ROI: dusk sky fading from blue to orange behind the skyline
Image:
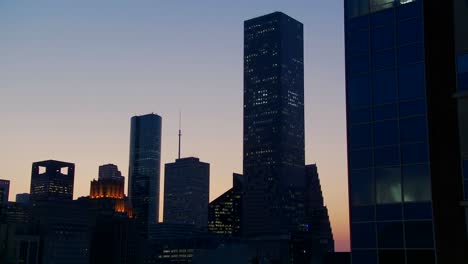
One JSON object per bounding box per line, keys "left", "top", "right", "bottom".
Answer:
{"left": 0, "top": 0, "right": 349, "bottom": 251}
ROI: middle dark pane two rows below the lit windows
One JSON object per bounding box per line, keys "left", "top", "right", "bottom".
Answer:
{"left": 377, "top": 222, "right": 403, "bottom": 250}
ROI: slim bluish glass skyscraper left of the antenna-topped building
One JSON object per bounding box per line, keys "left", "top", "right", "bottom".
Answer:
{"left": 128, "top": 114, "right": 161, "bottom": 235}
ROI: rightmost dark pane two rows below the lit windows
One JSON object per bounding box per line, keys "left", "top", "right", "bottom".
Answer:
{"left": 405, "top": 221, "right": 434, "bottom": 249}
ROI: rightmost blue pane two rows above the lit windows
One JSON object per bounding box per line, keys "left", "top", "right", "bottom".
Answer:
{"left": 400, "top": 117, "right": 427, "bottom": 143}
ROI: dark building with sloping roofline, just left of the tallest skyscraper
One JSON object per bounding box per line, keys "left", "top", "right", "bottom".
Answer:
{"left": 208, "top": 173, "right": 244, "bottom": 237}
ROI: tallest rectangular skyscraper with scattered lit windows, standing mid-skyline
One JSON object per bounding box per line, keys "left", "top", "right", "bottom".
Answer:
{"left": 243, "top": 12, "right": 305, "bottom": 237}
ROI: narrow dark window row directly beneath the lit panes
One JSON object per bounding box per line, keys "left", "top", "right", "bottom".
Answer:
{"left": 351, "top": 202, "right": 432, "bottom": 223}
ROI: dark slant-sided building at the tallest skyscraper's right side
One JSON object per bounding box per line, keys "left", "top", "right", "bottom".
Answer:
{"left": 306, "top": 164, "right": 335, "bottom": 252}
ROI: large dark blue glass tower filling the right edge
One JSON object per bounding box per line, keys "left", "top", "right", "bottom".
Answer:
{"left": 345, "top": 0, "right": 468, "bottom": 264}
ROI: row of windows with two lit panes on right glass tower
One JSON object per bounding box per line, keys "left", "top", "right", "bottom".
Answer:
{"left": 349, "top": 164, "right": 431, "bottom": 205}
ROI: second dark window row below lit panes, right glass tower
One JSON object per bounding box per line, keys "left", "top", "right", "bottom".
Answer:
{"left": 351, "top": 221, "right": 434, "bottom": 250}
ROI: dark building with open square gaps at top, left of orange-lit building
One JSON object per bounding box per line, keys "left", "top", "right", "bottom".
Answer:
{"left": 30, "top": 160, "right": 75, "bottom": 201}
